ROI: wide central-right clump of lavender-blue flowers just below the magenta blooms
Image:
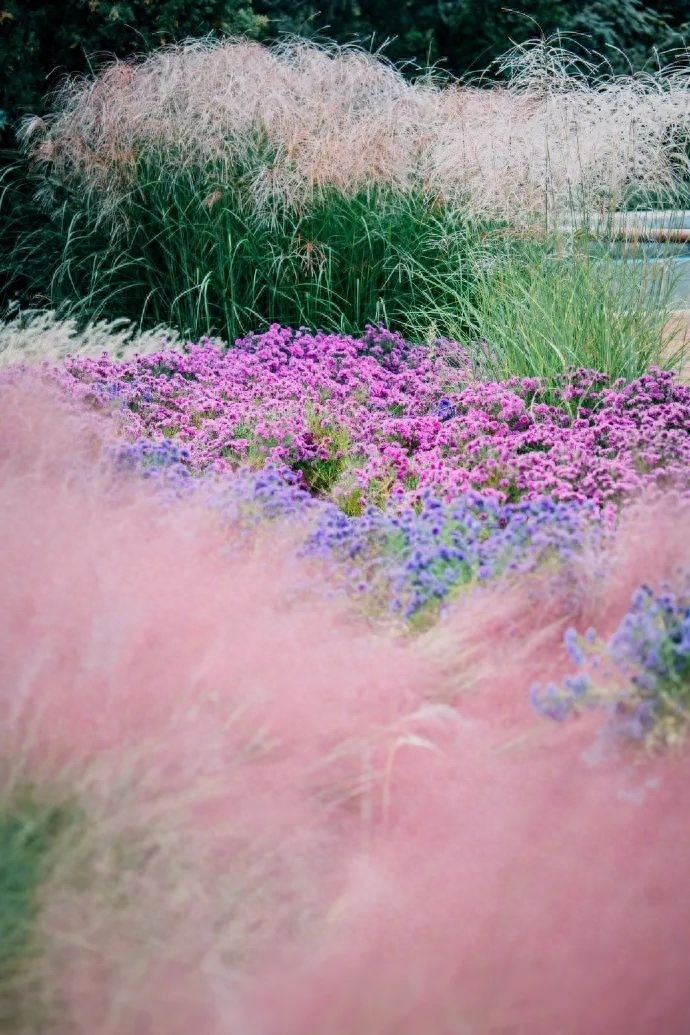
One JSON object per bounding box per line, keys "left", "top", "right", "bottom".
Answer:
{"left": 305, "top": 492, "right": 609, "bottom": 619}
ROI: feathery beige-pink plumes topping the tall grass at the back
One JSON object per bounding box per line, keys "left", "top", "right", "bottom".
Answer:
{"left": 24, "top": 38, "right": 690, "bottom": 221}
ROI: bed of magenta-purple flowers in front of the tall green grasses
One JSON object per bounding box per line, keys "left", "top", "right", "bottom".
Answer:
{"left": 55, "top": 325, "right": 690, "bottom": 513}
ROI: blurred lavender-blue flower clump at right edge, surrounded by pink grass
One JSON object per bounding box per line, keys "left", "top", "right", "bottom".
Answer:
{"left": 531, "top": 579, "right": 690, "bottom": 744}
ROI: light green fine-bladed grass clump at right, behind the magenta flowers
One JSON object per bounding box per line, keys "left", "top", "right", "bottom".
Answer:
{"left": 405, "top": 241, "right": 668, "bottom": 379}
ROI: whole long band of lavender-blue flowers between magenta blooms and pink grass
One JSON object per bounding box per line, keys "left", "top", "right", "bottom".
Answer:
{"left": 105, "top": 430, "right": 610, "bottom": 620}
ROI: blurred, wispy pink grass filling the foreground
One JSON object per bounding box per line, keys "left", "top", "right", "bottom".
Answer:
{"left": 0, "top": 377, "right": 690, "bottom": 1035}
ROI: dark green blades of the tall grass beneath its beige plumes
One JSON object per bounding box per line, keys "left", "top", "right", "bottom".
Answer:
{"left": 0, "top": 148, "right": 496, "bottom": 341}
